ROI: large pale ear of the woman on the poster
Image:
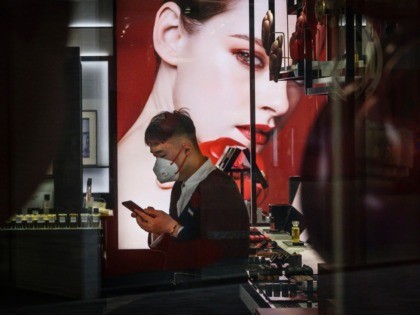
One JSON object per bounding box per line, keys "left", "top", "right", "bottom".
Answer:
{"left": 153, "top": 2, "right": 183, "bottom": 66}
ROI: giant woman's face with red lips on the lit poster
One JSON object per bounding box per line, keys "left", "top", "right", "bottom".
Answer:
{"left": 174, "top": 0, "right": 303, "bottom": 151}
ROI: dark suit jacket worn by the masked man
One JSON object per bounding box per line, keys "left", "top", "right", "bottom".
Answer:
{"left": 151, "top": 169, "right": 249, "bottom": 271}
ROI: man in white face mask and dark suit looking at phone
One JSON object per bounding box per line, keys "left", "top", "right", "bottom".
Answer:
{"left": 132, "top": 109, "right": 249, "bottom": 275}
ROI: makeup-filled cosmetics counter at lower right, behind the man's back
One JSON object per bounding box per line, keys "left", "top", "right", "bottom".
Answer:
{"left": 240, "top": 227, "right": 323, "bottom": 314}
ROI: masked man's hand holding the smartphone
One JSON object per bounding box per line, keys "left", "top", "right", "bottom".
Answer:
{"left": 131, "top": 207, "right": 177, "bottom": 234}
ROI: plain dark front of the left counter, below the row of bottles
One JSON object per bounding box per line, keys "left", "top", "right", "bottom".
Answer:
{"left": 0, "top": 229, "right": 102, "bottom": 299}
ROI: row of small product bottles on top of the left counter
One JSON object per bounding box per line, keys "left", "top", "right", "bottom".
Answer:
{"left": 3, "top": 208, "right": 101, "bottom": 229}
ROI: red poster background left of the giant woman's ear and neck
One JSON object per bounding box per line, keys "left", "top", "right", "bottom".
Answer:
{"left": 116, "top": 0, "right": 162, "bottom": 140}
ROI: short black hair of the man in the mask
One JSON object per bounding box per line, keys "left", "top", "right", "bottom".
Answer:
{"left": 144, "top": 108, "right": 198, "bottom": 147}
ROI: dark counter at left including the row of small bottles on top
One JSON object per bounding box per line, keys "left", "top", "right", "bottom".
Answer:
{"left": 0, "top": 210, "right": 110, "bottom": 299}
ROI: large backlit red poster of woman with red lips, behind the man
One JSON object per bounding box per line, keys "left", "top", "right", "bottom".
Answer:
{"left": 116, "top": 0, "right": 321, "bottom": 249}
